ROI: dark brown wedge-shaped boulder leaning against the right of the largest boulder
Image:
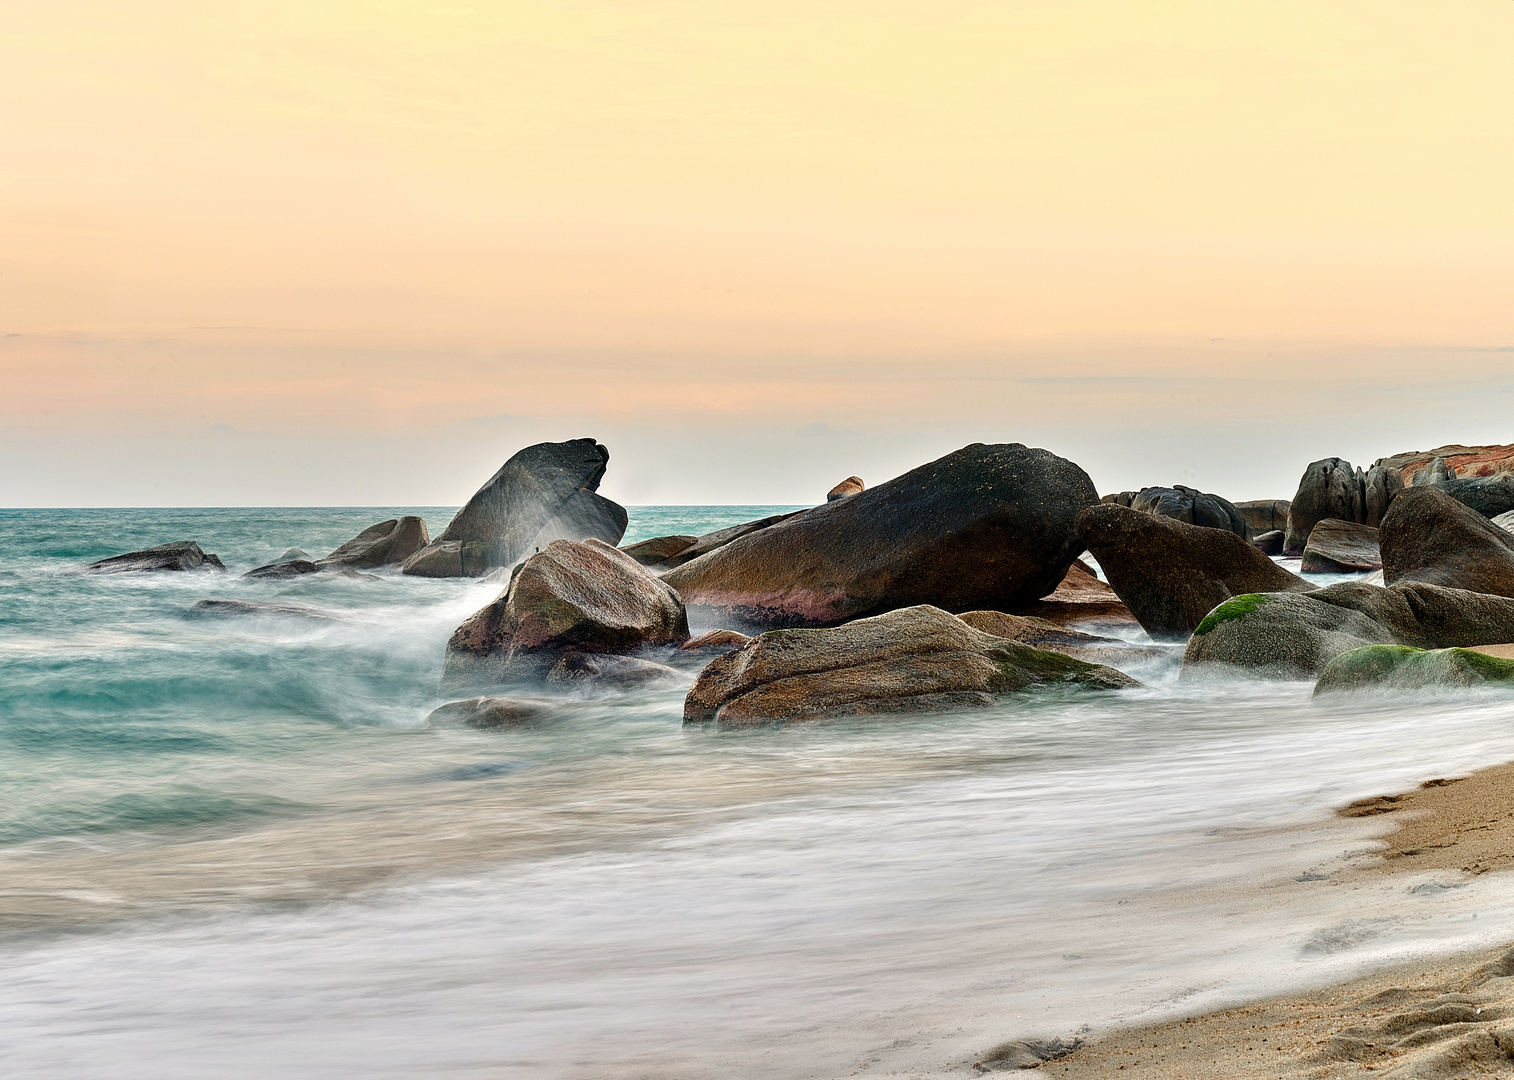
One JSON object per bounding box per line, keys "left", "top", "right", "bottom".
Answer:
{"left": 1078, "top": 504, "right": 1314, "bottom": 638}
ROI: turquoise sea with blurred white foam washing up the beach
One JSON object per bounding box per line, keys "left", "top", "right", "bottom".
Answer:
{"left": 0, "top": 506, "right": 1514, "bottom": 1078}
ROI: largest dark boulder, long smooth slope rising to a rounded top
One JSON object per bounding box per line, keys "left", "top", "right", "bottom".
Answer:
{"left": 663, "top": 442, "right": 1098, "bottom": 627}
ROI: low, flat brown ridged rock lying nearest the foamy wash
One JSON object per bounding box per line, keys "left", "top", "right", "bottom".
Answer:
{"left": 683, "top": 605, "right": 1140, "bottom": 724}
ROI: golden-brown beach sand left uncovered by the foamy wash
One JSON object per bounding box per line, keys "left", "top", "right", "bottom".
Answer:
{"left": 1029, "top": 763, "right": 1514, "bottom": 1080}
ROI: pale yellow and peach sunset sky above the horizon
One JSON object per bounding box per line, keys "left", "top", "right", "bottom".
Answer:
{"left": 0, "top": 0, "right": 1514, "bottom": 506}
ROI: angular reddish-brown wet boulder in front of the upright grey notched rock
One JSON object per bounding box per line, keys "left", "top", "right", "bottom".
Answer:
{"left": 442, "top": 539, "right": 689, "bottom": 686}
